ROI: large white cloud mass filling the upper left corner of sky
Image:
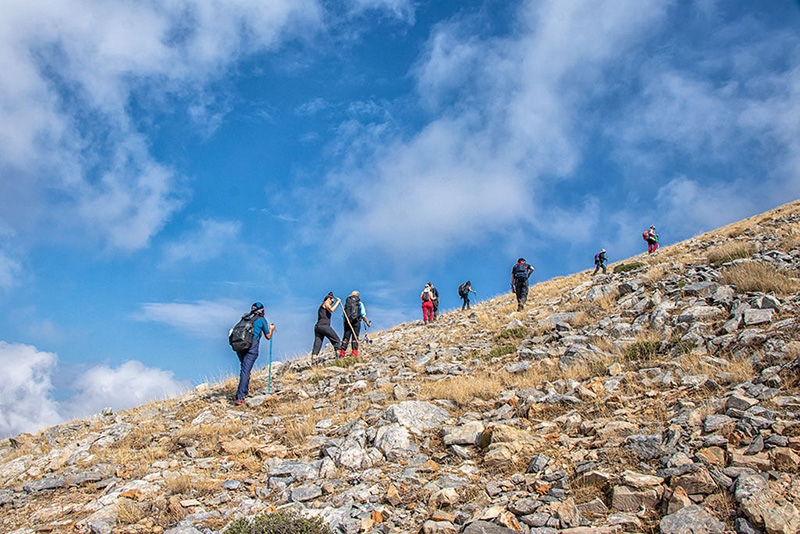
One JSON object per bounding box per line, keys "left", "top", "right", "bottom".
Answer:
{"left": 0, "top": 0, "right": 321, "bottom": 250}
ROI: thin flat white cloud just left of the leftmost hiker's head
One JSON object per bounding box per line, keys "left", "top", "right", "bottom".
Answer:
{"left": 133, "top": 300, "right": 244, "bottom": 339}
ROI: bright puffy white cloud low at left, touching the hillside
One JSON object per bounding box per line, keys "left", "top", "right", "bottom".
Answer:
{"left": 0, "top": 341, "right": 189, "bottom": 437}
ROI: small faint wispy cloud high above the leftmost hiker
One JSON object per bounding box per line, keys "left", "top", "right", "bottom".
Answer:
{"left": 165, "top": 219, "right": 241, "bottom": 263}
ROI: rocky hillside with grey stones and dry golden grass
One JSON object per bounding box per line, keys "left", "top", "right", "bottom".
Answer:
{"left": 0, "top": 202, "right": 800, "bottom": 534}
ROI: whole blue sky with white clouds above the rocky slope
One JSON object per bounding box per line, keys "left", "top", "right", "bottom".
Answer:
{"left": 0, "top": 0, "right": 800, "bottom": 435}
